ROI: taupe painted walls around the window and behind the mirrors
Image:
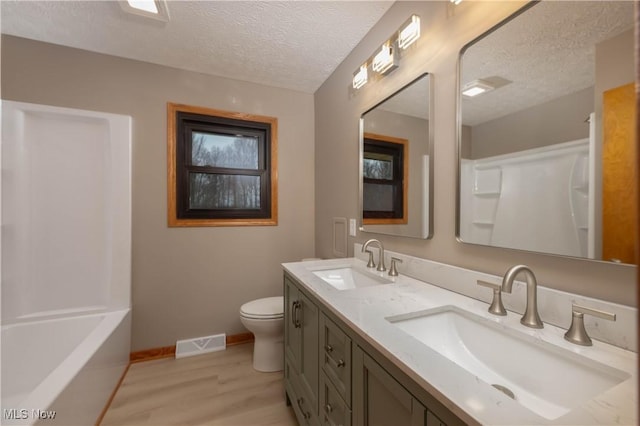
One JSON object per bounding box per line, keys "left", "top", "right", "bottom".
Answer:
{"left": 1, "top": 1, "right": 636, "bottom": 402}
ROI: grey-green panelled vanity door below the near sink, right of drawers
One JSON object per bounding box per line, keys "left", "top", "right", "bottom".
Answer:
{"left": 352, "top": 347, "right": 427, "bottom": 426}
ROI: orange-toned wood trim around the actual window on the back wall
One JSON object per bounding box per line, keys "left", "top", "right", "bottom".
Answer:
{"left": 167, "top": 102, "right": 278, "bottom": 227}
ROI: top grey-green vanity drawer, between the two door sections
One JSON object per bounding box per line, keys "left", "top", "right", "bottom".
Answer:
{"left": 320, "top": 315, "right": 351, "bottom": 407}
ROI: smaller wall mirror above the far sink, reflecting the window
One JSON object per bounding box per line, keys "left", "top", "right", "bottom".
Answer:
{"left": 359, "top": 74, "right": 433, "bottom": 238}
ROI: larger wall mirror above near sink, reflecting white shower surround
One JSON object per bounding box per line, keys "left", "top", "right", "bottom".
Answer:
{"left": 457, "top": 1, "right": 637, "bottom": 264}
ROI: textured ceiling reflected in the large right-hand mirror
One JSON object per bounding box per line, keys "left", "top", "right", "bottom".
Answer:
{"left": 461, "top": 1, "right": 634, "bottom": 126}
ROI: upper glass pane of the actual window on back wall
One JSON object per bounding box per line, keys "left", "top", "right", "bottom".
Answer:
{"left": 191, "top": 132, "right": 258, "bottom": 170}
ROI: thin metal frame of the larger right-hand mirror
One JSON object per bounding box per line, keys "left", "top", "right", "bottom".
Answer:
{"left": 455, "top": 0, "right": 636, "bottom": 267}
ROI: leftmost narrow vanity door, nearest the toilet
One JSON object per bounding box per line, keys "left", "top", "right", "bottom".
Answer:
{"left": 284, "top": 276, "right": 302, "bottom": 372}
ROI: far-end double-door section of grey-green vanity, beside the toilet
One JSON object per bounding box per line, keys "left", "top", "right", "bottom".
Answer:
{"left": 284, "top": 277, "right": 319, "bottom": 425}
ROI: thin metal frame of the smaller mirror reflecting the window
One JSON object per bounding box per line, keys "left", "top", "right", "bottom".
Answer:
{"left": 358, "top": 72, "right": 434, "bottom": 240}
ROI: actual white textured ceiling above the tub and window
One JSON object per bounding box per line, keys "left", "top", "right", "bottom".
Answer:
{"left": 0, "top": 0, "right": 393, "bottom": 93}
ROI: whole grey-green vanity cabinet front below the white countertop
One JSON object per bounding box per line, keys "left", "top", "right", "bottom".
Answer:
{"left": 284, "top": 273, "right": 463, "bottom": 426}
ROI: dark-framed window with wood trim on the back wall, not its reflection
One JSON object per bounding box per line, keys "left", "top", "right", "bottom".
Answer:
{"left": 167, "top": 103, "right": 278, "bottom": 226}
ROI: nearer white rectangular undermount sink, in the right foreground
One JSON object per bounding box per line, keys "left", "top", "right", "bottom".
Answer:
{"left": 386, "top": 306, "right": 631, "bottom": 420}
